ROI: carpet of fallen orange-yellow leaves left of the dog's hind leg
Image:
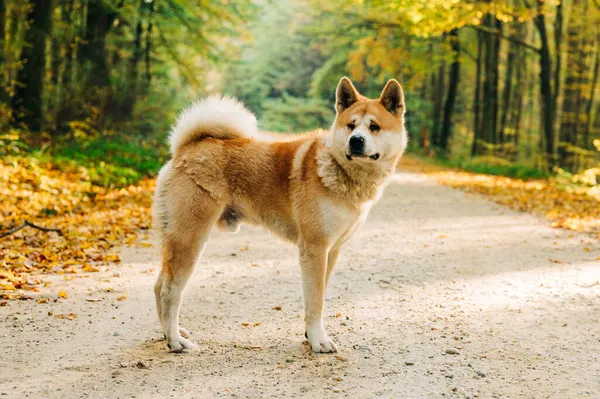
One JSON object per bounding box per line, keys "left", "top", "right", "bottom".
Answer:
{"left": 0, "top": 157, "right": 154, "bottom": 298}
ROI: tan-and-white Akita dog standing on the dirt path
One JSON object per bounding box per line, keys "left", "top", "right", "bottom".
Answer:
{"left": 153, "top": 77, "right": 408, "bottom": 353}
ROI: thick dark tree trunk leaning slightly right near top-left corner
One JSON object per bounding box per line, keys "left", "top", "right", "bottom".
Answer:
{"left": 12, "top": 0, "right": 52, "bottom": 132}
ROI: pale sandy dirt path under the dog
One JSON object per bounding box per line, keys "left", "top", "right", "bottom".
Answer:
{"left": 0, "top": 173, "right": 600, "bottom": 399}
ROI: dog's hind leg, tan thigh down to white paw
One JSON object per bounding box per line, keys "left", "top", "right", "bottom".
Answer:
{"left": 155, "top": 194, "right": 223, "bottom": 352}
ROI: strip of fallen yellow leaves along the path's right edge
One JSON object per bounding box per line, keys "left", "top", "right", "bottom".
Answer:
{"left": 400, "top": 157, "right": 600, "bottom": 238}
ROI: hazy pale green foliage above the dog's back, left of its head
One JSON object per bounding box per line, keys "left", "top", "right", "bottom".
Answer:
{"left": 224, "top": 1, "right": 332, "bottom": 132}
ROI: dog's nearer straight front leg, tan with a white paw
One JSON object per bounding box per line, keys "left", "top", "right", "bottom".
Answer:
{"left": 300, "top": 243, "right": 337, "bottom": 353}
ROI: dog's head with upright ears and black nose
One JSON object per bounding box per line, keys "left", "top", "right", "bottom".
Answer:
{"left": 328, "top": 77, "right": 407, "bottom": 166}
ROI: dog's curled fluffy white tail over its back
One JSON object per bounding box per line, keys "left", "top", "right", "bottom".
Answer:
{"left": 169, "top": 94, "right": 257, "bottom": 155}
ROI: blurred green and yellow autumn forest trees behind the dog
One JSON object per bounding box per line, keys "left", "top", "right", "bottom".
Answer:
{"left": 0, "top": 0, "right": 600, "bottom": 178}
